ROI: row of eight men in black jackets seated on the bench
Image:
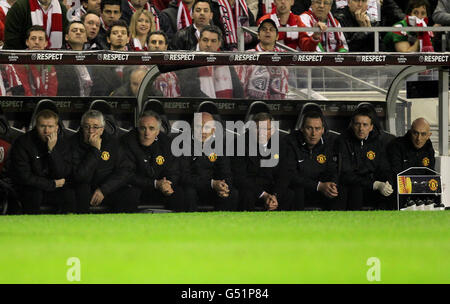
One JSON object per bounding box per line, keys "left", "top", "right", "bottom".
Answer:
{"left": 0, "top": 100, "right": 435, "bottom": 214}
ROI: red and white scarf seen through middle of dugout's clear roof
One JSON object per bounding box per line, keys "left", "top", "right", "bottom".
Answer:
{"left": 198, "top": 66, "right": 233, "bottom": 98}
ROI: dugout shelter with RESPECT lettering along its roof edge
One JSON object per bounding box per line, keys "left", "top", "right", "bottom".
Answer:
{"left": 0, "top": 50, "right": 450, "bottom": 205}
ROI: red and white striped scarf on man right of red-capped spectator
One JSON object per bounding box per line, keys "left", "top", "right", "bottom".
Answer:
{"left": 300, "top": 8, "right": 348, "bottom": 52}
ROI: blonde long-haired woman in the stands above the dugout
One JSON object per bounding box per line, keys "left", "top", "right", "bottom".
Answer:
{"left": 130, "top": 10, "right": 155, "bottom": 51}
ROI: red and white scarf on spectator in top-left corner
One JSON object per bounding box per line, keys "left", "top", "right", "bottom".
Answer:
{"left": 28, "top": 0, "right": 65, "bottom": 49}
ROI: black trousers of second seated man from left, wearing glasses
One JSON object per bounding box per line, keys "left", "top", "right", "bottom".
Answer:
{"left": 74, "top": 184, "right": 139, "bottom": 213}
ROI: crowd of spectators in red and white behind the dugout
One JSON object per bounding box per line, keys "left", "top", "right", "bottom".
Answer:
{"left": 0, "top": 0, "right": 450, "bottom": 99}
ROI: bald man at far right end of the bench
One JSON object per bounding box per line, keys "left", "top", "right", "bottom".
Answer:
{"left": 387, "top": 117, "right": 435, "bottom": 180}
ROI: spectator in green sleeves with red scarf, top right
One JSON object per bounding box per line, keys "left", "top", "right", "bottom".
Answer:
{"left": 384, "top": 0, "right": 434, "bottom": 53}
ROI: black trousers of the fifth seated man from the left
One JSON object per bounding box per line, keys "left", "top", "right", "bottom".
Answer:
{"left": 238, "top": 188, "right": 294, "bottom": 211}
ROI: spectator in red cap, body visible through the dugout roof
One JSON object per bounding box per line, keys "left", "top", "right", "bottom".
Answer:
{"left": 236, "top": 18, "right": 289, "bottom": 100}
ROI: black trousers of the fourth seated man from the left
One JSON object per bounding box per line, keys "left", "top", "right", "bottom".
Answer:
{"left": 184, "top": 187, "right": 239, "bottom": 211}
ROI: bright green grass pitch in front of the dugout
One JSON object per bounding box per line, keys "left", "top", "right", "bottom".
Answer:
{"left": 0, "top": 211, "right": 450, "bottom": 284}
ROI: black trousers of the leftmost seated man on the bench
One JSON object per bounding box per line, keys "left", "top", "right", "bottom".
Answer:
{"left": 18, "top": 186, "right": 76, "bottom": 214}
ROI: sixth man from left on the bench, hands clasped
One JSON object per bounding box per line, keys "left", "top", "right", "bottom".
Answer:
{"left": 286, "top": 111, "right": 345, "bottom": 210}
